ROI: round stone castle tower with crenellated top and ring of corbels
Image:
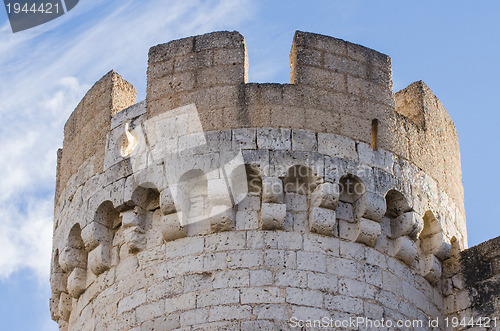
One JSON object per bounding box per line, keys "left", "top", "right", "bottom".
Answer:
{"left": 50, "top": 31, "right": 500, "bottom": 330}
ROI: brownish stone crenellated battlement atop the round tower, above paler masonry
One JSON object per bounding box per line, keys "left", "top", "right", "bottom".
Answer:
{"left": 58, "top": 32, "right": 463, "bottom": 218}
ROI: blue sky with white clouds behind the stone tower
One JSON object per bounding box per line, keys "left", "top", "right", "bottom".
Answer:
{"left": 0, "top": 0, "right": 500, "bottom": 330}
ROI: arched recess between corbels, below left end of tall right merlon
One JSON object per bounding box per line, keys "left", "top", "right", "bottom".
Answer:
{"left": 283, "top": 165, "right": 321, "bottom": 232}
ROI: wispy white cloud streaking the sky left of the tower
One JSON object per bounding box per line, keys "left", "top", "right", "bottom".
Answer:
{"left": 0, "top": 0, "right": 252, "bottom": 280}
